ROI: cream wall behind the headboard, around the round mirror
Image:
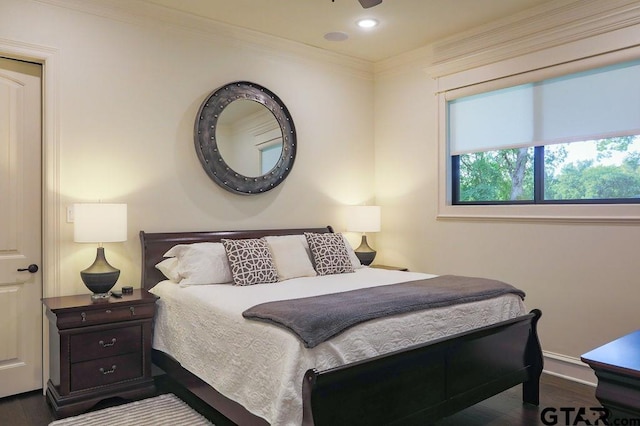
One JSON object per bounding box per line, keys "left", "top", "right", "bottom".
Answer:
{"left": 0, "top": 0, "right": 374, "bottom": 296}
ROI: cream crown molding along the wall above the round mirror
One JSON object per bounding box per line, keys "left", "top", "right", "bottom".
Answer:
{"left": 35, "top": 0, "right": 374, "bottom": 80}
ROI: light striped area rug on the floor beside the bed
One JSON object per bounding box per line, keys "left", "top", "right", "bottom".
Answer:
{"left": 49, "top": 393, "right": 212, "bottom": 426}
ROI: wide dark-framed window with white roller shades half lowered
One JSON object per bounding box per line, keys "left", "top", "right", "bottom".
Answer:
{"left": 447, "top": 61, "right": 640, "bottom": 204}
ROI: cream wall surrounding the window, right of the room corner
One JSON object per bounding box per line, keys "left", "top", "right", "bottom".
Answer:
{"left": 375, "top": 0, "right": 640, "bottom": 381}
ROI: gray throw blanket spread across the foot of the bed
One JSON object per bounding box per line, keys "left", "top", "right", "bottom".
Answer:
{"left": 242, "top": 275, "right": 525, "bottom": 348}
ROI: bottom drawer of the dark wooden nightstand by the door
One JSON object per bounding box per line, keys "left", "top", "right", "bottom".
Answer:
{"left": 71, "top": 352, "right": 142, "bottom": 392}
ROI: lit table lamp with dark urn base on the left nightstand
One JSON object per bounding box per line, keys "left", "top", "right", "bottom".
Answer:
{"left": 73, "top": 203, "right": 127, "bottom": 300}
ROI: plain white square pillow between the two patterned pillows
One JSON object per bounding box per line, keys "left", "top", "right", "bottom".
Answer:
{"left": 264, "top": 235, "right": 318, "bottom": 281}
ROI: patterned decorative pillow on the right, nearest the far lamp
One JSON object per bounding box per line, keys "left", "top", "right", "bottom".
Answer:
{"left": 304, "top": 232, "right": 353, "bottom": 275}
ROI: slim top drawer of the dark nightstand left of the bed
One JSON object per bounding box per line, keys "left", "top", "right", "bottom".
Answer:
{"left": 57, "top": 304, "right": 155, "bottom": 330}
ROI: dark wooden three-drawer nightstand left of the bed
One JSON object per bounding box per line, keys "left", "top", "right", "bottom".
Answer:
{"left": 42, "top": 290, "right": 158, "bottom": 417}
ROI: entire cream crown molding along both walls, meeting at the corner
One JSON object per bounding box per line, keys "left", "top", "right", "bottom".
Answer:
{"left": 35, "top": 0, "right": 640, "bottom": 80}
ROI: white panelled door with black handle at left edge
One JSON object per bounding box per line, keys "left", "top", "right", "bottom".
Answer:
{"left": 0, "top": 58, "right": 42, "bottom": 398}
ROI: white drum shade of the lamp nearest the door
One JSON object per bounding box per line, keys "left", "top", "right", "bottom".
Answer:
{"left": 73, "top": 203, "right": 127, "bottom": 243}
